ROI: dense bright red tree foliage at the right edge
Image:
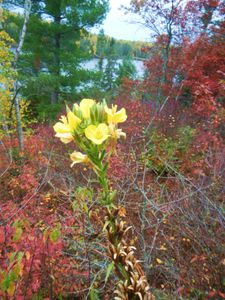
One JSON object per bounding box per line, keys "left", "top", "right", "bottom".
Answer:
{"left": 180, "top": 21, "right": 225, "bottom": 119}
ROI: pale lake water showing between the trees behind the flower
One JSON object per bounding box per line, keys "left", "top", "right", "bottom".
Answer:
{"left": 81, "top": 58, "right": 145, "bottom": 78}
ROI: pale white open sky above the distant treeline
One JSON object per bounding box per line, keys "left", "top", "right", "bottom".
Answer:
{"left": 94, "top": 0, "right": 150, "bottom": 41}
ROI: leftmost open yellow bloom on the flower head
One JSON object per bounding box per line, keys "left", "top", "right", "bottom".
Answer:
{"left": 53, "top": 111, "right": 81, "bottom": 144}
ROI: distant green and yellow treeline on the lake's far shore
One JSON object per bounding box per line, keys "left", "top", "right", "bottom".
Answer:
{"left": 80, "top": 30, "right": 151, "bottom": 59}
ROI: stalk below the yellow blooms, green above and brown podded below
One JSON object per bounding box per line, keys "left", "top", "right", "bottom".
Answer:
{"left": 95, "top": 161, "right": 155, "bottom": 300}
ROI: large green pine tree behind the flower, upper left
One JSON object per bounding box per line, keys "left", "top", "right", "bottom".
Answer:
{"left": 5, "top": 0, "right": 108, "bottom": 104}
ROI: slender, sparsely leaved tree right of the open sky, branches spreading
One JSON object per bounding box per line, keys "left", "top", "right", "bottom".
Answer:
{"left": 127, "top": 0, "right": 222, "bottom": 108}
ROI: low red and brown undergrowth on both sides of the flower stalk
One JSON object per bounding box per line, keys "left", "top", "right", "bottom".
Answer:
{"left": 0, "top": 97, "right": 225, "bottom": 299}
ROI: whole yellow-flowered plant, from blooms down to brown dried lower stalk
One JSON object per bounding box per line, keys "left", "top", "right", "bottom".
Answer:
{"left": 53, "top": 99, "right": 154, "bottom": 300}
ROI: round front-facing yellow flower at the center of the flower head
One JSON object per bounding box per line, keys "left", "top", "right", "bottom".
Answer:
{"left": 85, "top": 123, "right": 109, "bottom": 145}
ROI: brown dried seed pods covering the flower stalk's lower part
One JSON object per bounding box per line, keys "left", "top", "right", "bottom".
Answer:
{"left": 105, "top": 209, "right": 155, "bottom": 300}
